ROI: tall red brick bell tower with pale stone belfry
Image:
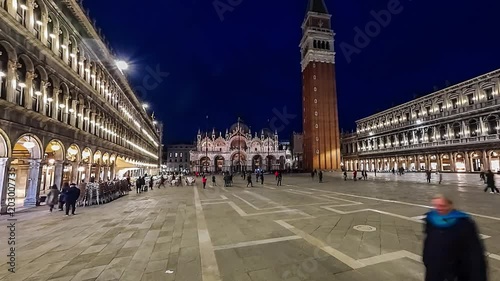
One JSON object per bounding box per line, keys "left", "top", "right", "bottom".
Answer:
{"left": 300, "top": 0, "right": 341, "bottom": 171}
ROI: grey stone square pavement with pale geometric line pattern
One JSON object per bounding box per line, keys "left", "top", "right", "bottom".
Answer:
{"left": 0, "top": 174, "right": 500, "bottom": 281}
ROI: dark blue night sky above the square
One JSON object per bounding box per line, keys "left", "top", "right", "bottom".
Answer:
{"left": 84, "top": 0, "right": 500, "bottom": 143}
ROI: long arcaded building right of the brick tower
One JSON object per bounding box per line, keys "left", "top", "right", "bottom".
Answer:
{"left": 342, "top": 70, "right": 500, "bottom": 172}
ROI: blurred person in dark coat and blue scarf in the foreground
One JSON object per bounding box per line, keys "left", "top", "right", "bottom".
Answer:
{"left": 423, "top": 195, "right": 487, "bottom": 281}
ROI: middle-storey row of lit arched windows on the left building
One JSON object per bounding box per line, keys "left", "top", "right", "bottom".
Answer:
{"left": 0, "top": 41, "right": 157, "bottom": 156}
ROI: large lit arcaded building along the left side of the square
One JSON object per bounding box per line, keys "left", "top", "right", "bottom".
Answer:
{"left": 0, "top": 0, "right": 162, "bottom": 211}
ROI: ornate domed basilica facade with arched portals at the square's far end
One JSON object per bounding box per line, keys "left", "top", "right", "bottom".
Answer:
{"left": 190, "top": 121, "right": 288, "bottom": 173}
